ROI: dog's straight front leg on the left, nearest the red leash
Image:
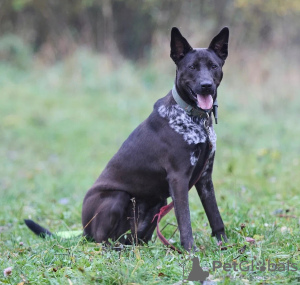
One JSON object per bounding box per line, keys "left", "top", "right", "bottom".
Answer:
{"left": 169, "top": 176, "right": 194, "bottom": 251}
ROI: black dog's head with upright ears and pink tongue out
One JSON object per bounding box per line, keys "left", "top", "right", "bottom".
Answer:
{"left": 170, "top": 27, "right": 229, "bottom": 111}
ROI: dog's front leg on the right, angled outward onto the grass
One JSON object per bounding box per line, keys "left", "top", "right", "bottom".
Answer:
{"left": 195, "top": 157, "right": 227, "bottom": 242}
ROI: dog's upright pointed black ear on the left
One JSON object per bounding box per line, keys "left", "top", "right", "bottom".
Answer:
{"left": 170, "top": 27, "right": 193, "bottom": 64}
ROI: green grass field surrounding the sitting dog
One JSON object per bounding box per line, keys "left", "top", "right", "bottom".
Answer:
{"left": 0, "top": 50, "right": 300, "bottom": 284}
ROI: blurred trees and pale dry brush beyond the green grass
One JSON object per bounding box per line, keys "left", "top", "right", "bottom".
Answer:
{"left": 0, "top": 0, "right": 300, "bottom": 109}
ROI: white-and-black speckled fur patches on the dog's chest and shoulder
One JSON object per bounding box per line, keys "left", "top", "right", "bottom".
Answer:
{"left": 158, "top": 105, "right": 217, "bottom": 165}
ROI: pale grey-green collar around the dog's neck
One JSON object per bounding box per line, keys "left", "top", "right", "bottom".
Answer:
{"left": 172, "top": 84, "right": 218, "bottom": 124}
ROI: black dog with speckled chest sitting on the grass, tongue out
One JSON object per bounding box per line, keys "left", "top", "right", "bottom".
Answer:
{"left": 27, "top": 27, "right": 229, "bottom": 250}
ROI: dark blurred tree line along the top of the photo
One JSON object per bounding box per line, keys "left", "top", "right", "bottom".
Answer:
{"left": 0, "top": 0, "right": 300, "bottom": 60}
